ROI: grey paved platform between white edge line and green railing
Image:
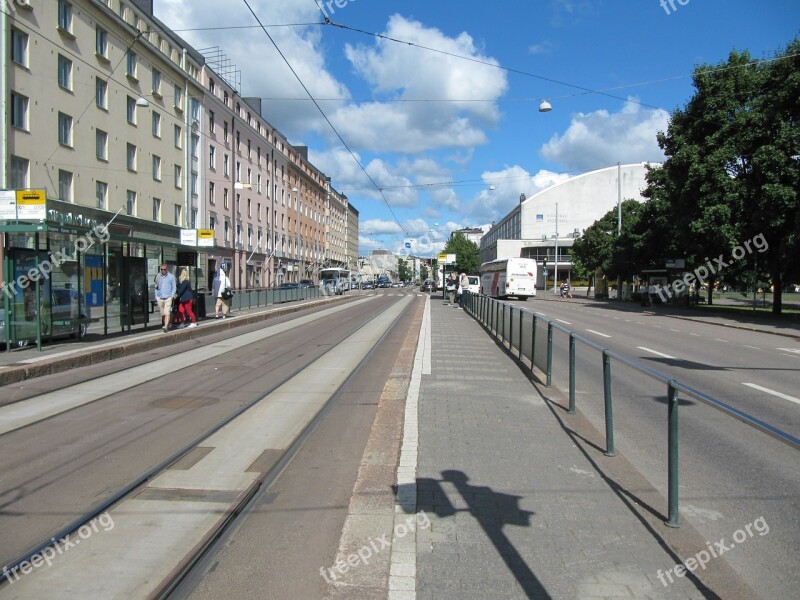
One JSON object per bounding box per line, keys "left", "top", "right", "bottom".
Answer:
{"left": 412, "top": 295, "right": 755, "bottom": 600}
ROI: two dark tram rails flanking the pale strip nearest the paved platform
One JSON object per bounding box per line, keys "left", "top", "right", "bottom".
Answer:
{"left": 0, "top": 292, "right": 410, "bottom": 597}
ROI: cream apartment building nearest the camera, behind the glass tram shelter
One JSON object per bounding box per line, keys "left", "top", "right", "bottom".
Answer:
{"left": 0, "top": 0, "right": 203, "bottom": 337}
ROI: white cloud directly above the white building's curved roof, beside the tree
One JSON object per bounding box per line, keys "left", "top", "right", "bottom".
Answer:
{"left": 541, "top": 97, "right": 669, "bottom": 171}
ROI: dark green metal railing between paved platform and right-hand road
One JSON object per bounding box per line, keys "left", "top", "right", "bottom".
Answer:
{"left": 464, "top": 292, "right": 800, "bottom": 527}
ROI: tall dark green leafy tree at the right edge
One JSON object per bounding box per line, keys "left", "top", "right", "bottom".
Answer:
{"left": 644, "top": 39, "right": 800, "bottom": 314}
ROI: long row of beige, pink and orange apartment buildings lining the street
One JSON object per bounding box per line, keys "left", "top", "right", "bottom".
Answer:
{"left": 0, "top": 0, "right": 356, "bottom": 340}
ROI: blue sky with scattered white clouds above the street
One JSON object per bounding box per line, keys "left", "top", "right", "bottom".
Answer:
{"left": 154, "top": 0, "right": 800, "bottom": 256}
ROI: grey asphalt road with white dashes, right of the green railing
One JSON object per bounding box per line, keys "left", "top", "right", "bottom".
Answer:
{"left": 504, "top": 299, "right": 800, "bottom": 598}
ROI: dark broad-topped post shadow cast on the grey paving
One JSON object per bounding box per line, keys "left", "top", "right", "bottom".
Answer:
{"left": 416, "top": 470, "right": 551, "bottom": 600}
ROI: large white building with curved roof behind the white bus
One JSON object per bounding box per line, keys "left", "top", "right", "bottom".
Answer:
{"left": 480, "top": 163, "right": 647, "bottom": 287}
